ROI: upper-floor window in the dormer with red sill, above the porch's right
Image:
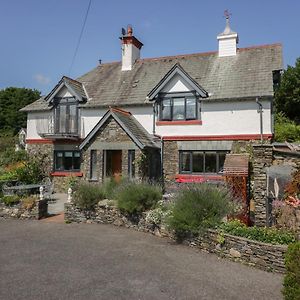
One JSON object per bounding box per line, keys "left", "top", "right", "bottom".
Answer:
{"left": 160, "top": 96, "right": 197, "bottom": 121}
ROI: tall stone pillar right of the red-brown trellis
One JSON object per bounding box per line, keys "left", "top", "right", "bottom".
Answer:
{"left": 253, "top": 145, "right": 273, "bottom": 226}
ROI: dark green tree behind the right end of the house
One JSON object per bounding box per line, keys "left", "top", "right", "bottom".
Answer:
{"left": 275, "top": 57, "right": 300, "bottom": 124}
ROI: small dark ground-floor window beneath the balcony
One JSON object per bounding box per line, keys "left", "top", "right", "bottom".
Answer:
{"left": 54, "top": 150, "right": 80, "bottom": 171}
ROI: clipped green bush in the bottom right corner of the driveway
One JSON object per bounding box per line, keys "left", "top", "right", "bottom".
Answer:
{"left": 282, "top": 242, "right": 300, "bottom": 300}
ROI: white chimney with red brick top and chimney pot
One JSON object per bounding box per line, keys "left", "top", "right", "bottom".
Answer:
{"left": 120, "top": 26, "right": 143, "bottom": 71}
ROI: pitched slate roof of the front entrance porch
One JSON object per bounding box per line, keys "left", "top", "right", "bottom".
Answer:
{"left": 79, "top": 108, "right": 159, "bottom": 150}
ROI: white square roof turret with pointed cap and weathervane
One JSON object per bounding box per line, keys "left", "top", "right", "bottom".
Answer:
{"left": 217, "top": 11, "right": 239, "bottom": 57}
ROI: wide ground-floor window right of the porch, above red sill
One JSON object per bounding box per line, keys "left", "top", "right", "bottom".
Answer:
{"left": 179, "top": 151, "right": 228, "bottom": 173}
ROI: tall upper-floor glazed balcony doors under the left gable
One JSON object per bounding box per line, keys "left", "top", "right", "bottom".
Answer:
{"left": 55, "top": 97, "right": 78, "bottom": 134}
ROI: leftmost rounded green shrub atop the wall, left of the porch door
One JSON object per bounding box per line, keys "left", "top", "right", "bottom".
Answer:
{"left": 73, "top": 182, "right": 105, "bottom": 211}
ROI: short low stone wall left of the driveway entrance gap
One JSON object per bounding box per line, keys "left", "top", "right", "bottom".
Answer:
{"left": 0, "top": 199, "right": 48, "bottom": 220}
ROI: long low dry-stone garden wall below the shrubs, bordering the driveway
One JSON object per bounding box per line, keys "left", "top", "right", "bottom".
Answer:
{"left": 65, "top": 200, "right": 287, "bottom": 273}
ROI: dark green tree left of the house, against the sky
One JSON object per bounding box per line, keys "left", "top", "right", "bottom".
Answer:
{"left": 0, "top": 87, "right": 41, "bottom": 135}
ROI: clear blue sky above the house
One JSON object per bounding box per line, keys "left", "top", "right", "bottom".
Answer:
{"left": 0, "top": 0, "right": 300, "bottom": 94}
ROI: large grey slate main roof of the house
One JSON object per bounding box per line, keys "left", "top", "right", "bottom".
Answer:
{"left": 21, "top": 44, "right": 283, "bottom": 109}
